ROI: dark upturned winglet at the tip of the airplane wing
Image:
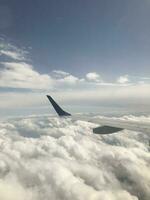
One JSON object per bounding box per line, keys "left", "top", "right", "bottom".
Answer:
{"left": 46, "top": 95, "right": 71, "bottom": 117}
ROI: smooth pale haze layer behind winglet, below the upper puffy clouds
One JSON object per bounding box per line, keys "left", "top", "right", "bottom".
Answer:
{"left": 0, "top": 82, "right": 150, "bottom": 113}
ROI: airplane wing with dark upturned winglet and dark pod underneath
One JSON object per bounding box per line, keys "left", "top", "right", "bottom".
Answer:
{"left": 46, "top": 95, "right": 150, "bottom": 135}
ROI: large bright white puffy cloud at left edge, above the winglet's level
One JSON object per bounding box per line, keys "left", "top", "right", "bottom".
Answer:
{"left": 0, "top": 62, "right": 52, "bottom": 89}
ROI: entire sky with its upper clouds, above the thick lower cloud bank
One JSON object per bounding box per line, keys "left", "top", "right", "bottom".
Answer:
{"left": 0, "top": 0, "right": 150, "bottom": 115}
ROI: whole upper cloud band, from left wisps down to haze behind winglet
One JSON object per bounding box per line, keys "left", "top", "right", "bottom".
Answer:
{"left": 0, "top": 38, "right": 150, "bottom": 115}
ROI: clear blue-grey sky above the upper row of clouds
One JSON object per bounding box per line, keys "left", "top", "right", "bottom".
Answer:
{"left": 0, "top": 0, "right": 150, "bottom": 78}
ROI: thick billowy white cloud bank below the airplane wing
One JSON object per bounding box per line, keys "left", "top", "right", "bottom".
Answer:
{"left": 0, "top": 116, "right": 150, "bottom": 200}
